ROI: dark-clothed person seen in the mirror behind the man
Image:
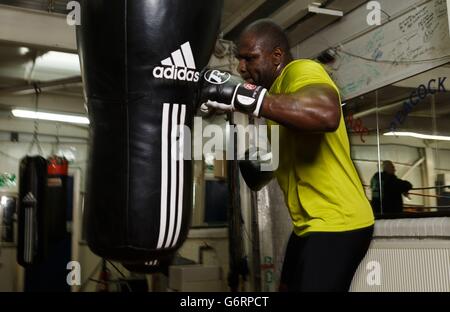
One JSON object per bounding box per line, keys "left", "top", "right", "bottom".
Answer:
{"left": 370, "top": 160, "right": 413, "bottom": 214}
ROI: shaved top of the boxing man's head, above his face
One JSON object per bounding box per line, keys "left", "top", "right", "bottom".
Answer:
{"left": 241, "top": 19, "right": 290, "bottom": 53}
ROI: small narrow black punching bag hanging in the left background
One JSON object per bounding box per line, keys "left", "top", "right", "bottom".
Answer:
{"left": 17, "top": 156, "right": 48, "bottom": 267}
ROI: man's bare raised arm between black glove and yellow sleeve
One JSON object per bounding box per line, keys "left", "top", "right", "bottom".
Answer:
{"left": 261, "top": 84, "right": 341, "bottom": 132}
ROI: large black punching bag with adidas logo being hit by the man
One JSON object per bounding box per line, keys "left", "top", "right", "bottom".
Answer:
{"left": 77, "top": 0, "right": 223, "bottom": 263}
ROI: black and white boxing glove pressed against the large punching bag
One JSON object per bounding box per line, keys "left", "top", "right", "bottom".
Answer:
{"left": 198, "top": 69, "right": 267, "bottom": 117}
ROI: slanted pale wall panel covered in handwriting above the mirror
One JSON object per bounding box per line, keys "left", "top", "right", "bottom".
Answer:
{"left": 330, "top": 0, "right": 450, "bottom": 100}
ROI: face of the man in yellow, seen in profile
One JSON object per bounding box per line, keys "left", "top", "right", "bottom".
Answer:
{"left": 236, "top": 33, "right": 278, "bottom": 89}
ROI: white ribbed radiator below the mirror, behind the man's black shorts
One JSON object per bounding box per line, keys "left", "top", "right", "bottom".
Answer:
{"left": 350, "top": 237, "right": 450, "bottom": 292}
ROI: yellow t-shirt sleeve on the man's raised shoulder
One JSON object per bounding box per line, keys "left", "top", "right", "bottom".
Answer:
{"left": 280, "top": 60, "right": 339, "bottom": 94}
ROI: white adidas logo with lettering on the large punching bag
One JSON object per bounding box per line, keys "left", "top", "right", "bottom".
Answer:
{"left": 153, "top": 41, "right": 200, "bottom": 82}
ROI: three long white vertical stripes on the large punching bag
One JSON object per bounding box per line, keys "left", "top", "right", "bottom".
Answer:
{"left": 157, "top": 103, "right": 186, "bottom": 249}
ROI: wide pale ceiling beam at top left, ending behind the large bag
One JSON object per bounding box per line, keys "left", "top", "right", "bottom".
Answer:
{"left": 0, "top": 5, "right": 77, "bottom": 53}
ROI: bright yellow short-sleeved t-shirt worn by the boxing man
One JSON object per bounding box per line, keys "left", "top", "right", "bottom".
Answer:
{"left": 268, "top": 60, "right": 374, "bottom": 236}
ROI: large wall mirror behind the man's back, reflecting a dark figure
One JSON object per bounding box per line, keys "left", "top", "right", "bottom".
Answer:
{"left": 344, "top": 64, "right": 450, "bottom": 218}
